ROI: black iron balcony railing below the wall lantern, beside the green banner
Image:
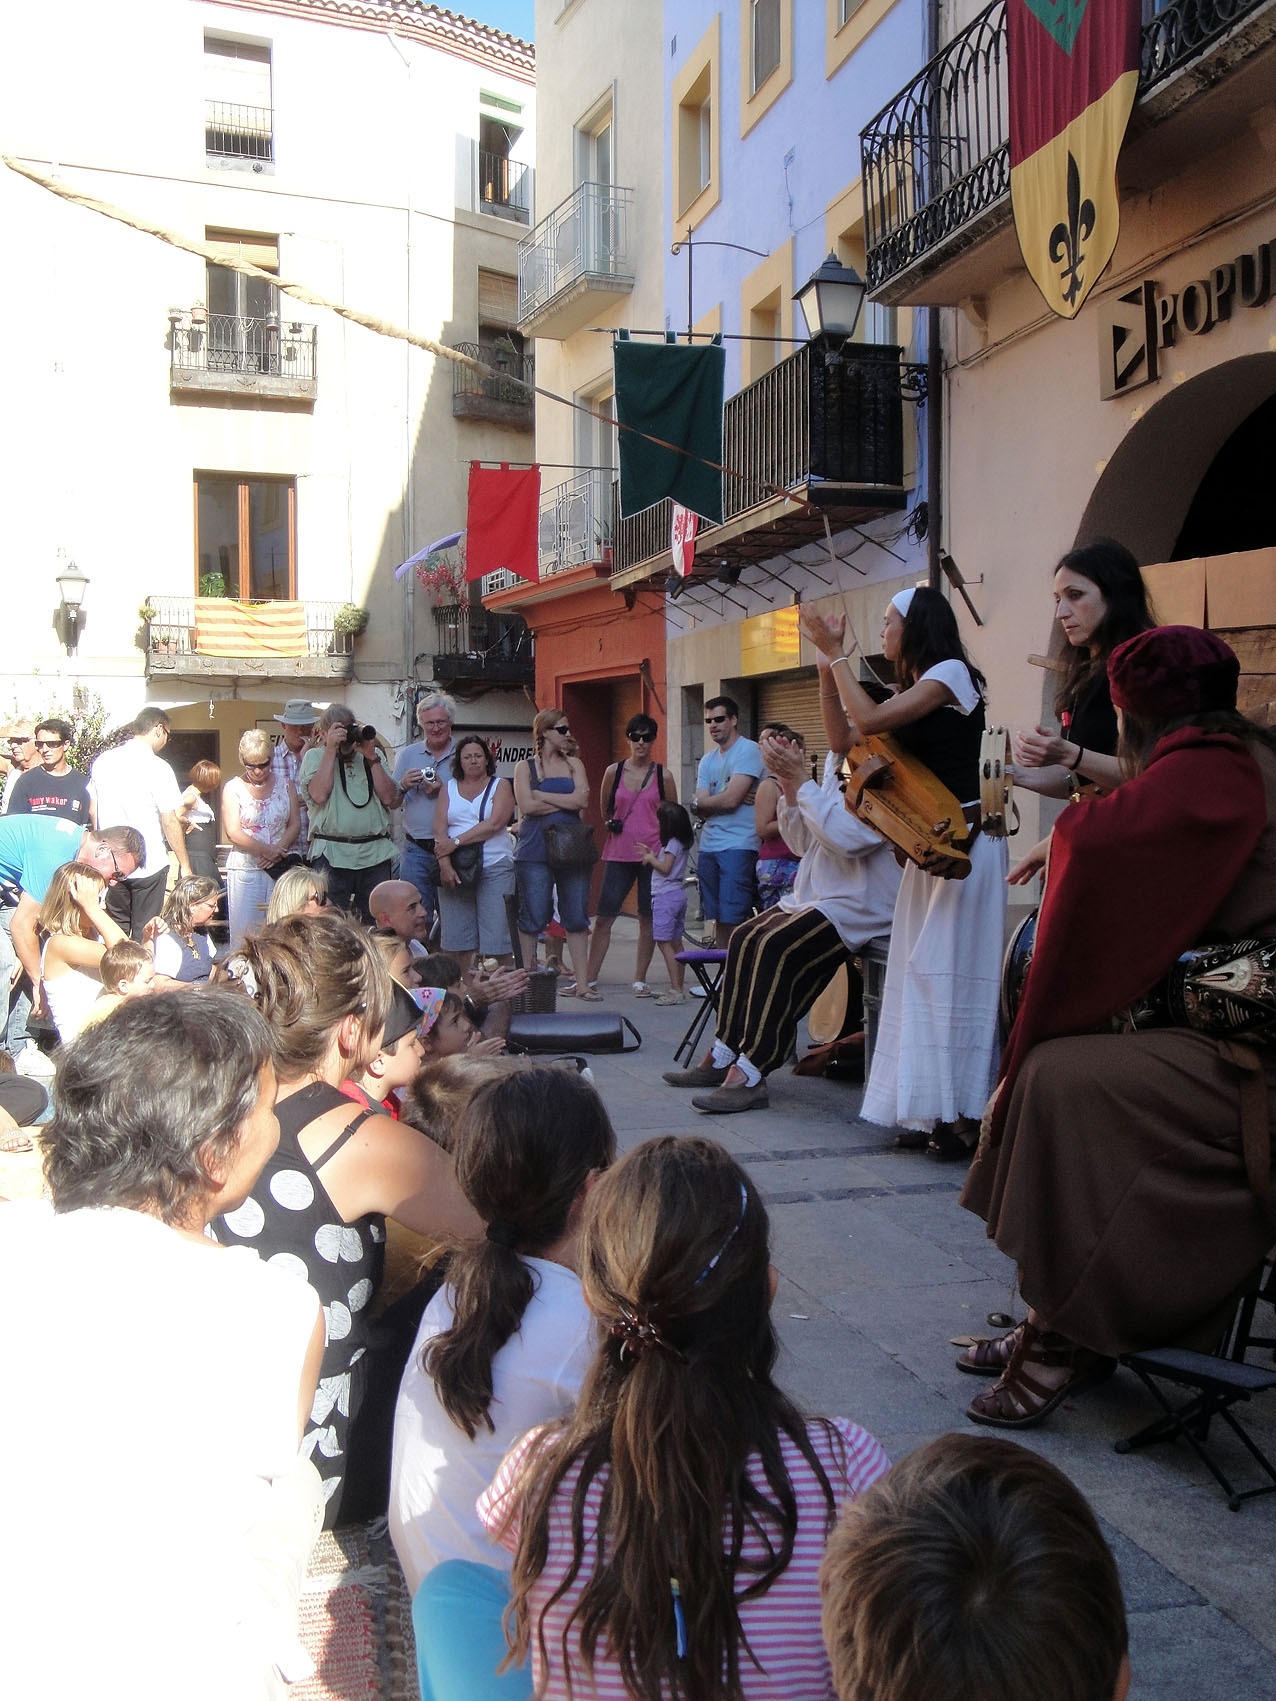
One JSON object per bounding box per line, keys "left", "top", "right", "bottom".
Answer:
{"left": 612, "top": 342, "right": 903, "bottom": 573}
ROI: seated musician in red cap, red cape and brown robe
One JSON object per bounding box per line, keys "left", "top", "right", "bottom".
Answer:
{"left": 958, "top": 626, "right": 1276, "bottom": 1429}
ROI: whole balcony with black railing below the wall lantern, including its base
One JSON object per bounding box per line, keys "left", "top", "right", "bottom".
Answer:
{"left": 611, "top": 342, "right": 907, "bottom": 589}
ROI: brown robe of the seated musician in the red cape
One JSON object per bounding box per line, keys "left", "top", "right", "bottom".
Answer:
{"left": 961, "top": 745, "right": 1276, "bottom": 1354}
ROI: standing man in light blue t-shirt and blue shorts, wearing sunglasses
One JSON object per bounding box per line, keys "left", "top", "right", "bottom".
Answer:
{"left": 691, "top": 697, "right": 766, "bottom": 951}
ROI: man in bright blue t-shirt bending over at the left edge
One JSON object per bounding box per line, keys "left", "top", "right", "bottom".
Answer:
{"left": 0, "top": 815, "right": 146, "bottom": 1041}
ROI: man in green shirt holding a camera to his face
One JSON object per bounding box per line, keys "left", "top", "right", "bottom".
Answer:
{"left": 298, "top": 703, "right": 400, "bottom": 925}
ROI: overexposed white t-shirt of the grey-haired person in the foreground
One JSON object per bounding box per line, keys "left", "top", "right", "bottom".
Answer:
{"left": 0, "top": 1199, "right": 318, "bottom": 1701}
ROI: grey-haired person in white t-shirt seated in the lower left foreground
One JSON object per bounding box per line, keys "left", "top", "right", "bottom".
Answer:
{"left": 0, "top": 990, "right": 323, "bottom": 1701}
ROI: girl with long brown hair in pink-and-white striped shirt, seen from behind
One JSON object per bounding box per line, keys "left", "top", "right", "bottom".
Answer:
{"left": 480, "top": 1138, "right": 888, "bottom": 1701}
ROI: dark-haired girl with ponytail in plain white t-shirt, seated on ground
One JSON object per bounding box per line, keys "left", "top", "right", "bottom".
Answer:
{"left": 390, "top": 1067, "right": 616, "bottom": 1698}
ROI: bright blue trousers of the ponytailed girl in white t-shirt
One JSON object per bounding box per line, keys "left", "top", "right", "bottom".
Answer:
{"left": 412, "top": 1560, "right": 533, "bottom": 1701}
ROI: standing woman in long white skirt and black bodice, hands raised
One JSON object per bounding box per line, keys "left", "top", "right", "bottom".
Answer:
{"left": 801, "top": 589, "right": 1005, "bottom": 1160}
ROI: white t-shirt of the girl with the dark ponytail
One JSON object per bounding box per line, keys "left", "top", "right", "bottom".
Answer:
{"left": 390, "top": 1259, "right": 595, "bottom": 1594}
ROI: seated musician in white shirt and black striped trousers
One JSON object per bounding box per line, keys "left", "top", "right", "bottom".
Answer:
{"left": 665, "top": 717, "right": 900, "bottom": 1114}
